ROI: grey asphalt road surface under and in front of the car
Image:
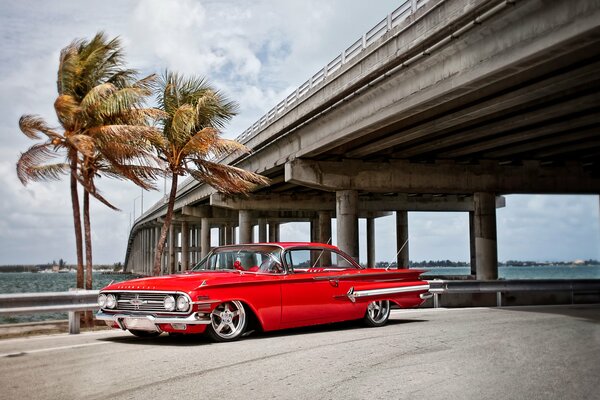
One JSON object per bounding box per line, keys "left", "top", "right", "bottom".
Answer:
{"left": 0, "top": 305, "right": 600, "bottom": 400}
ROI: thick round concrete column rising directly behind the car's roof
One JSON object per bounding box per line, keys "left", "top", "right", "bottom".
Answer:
{"left": 335, "top": 190, "right": 358, "bottom": 261}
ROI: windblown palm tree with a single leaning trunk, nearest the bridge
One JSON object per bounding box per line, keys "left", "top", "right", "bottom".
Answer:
{"left": 153, "top": 71, "right": 268, "bottom": 275}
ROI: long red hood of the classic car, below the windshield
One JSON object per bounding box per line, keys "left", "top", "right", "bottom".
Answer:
{"left": 101, "top": 271, "right": 272, "bottom": 292}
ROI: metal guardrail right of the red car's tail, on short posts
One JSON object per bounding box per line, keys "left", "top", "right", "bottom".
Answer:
{"left": 428, "top": 279, "right": 600, "bottom": 308}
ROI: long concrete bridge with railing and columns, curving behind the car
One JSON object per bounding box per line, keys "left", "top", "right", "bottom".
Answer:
{"left": 125, "top": 0, "right": 600, "bottom": 279}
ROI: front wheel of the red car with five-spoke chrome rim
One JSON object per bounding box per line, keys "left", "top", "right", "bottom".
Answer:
{"left": 207, "top": 300, "right": 247, "bottom": 342}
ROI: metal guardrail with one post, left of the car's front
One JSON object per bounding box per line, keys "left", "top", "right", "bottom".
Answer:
{"left": 0, "top": 290, "right": 99, "bottom": 334}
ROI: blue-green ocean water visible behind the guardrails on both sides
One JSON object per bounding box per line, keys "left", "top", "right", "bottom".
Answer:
{"left": 0, "top": 265, "right": 600, "bottom": 324}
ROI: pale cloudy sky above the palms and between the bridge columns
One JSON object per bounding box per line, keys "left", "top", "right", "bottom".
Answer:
{"left": 0, "top": 0, "right": 600, "bottom": 265}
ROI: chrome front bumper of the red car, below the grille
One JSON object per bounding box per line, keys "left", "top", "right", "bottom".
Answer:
{"left": 96, "top": 311, "right": 210, "bottom": 332}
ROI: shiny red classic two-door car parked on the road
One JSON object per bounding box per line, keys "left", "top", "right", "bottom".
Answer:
{"left": 96, "top": 243, "right": 430, "bottom": 341}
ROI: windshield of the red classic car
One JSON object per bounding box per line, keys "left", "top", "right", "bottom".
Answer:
{"left": 193, "top": 246, "right": 283, "bottom": 273}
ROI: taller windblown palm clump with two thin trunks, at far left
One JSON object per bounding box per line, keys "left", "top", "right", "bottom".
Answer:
{"left": 17, "top": 32, "right": 160, "bottom": 289}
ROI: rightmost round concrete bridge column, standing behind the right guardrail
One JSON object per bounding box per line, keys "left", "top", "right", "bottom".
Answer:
{"left": 473, "top": 192, "right": 498, "bottom": 280}
